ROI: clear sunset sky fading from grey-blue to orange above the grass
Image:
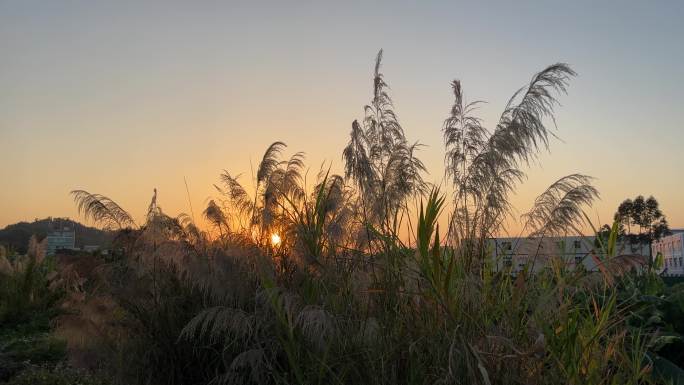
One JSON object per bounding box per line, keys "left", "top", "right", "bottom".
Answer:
{"left": 0, "top": 0, "right": 684, "bottom": 231}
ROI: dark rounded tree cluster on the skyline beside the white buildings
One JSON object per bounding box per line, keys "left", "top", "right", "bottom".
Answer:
{"left": 615, "top": 195, "right": 670, "bottom": 244}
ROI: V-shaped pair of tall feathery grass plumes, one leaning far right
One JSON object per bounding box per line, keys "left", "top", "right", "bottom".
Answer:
{"left": 443, "top": 64, "right": 576, "bottom": 264}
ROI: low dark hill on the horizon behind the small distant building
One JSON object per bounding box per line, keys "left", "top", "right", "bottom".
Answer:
{"left": 0, "top": 218, "right": 113, "bottom": 254}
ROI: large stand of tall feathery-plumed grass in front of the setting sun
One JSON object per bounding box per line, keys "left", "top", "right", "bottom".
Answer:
{"left": 58, "top": 51, "right": 680, "bottom": 384}
